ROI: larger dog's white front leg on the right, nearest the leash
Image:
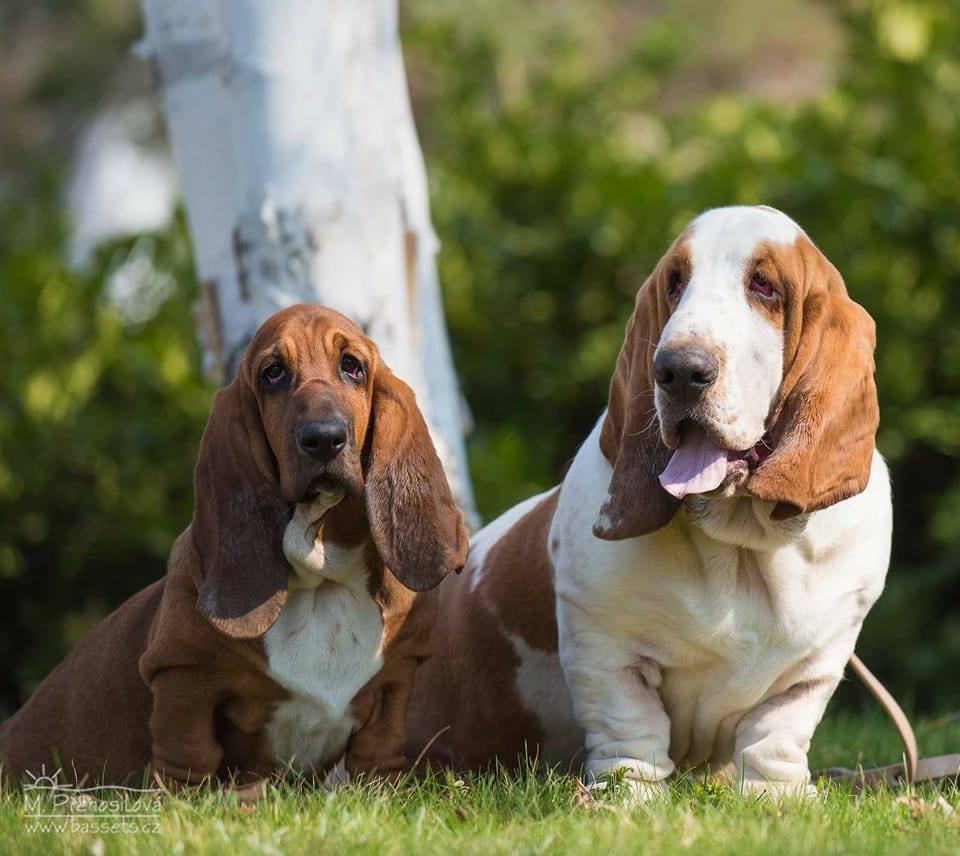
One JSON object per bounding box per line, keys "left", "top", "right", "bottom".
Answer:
{"left": 735, "top": 677, "right": 838, "bottom": 796}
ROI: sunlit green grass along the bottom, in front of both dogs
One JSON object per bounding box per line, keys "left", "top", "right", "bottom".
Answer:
{"left": 0, "top": 714, "right": 960, "bottom": 856}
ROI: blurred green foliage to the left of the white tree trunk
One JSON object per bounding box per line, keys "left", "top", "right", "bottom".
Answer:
{"left": 0, "top": 182, "right": 212, "bottom": 711}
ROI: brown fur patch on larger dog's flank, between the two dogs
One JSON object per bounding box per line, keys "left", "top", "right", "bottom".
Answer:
{"left": 408, "top": 491, "right": 582, "bottom": 768}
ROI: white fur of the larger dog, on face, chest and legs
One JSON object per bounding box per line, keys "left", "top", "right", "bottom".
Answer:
{"left": 476, "top": 208, "right": 892, "bottom": 795}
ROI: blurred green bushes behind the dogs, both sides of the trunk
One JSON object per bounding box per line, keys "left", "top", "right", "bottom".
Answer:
{"left": 0, "top": 2, "right": 960, "bottom": 711}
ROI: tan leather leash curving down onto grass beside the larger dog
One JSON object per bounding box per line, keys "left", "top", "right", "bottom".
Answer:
{"left": 814, "top": 654, "right": 960, "bottom": 790}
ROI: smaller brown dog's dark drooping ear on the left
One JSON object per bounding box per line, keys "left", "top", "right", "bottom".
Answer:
{"left": 190, "top": 374, "right": 288, "bottom": 639}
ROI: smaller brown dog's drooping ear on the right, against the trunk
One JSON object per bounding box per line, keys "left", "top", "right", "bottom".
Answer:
{"left": 364, "top": 363, "right": 467, "bottom": 591}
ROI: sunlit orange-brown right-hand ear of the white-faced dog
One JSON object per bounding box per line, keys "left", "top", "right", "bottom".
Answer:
{"left": 747, "top": 244, "right": 880, "bottom": 520}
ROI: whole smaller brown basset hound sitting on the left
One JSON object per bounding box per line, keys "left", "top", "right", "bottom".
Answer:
{"left": 0, "top": 306, "right": 466, "bottom": 784}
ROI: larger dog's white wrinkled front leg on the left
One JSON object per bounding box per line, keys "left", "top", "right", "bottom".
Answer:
{"left": 558, "top": 601, "right": 674, "bottom": 799}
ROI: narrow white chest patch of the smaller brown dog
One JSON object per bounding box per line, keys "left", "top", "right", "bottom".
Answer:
{"left": 264, "top": 498, "right": 383, "bottom": 769}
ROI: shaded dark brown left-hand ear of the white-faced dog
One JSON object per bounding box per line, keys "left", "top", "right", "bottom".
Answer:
{"left": 593, "top": 261, "right": 680, "bottom": 541}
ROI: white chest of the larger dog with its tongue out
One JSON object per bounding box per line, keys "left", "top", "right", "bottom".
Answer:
{"left": 551, "top": 420, "right": 891, "bottom": 762}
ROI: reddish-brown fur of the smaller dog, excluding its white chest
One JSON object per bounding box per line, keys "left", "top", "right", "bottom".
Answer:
{"left": 0, "top": 306, "right": 466, "bottom": 784}
